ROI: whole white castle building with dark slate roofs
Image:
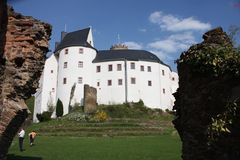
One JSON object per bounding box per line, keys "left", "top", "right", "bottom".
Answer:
{"left": 34, "top": 28, "right": 178, "bottom": 121}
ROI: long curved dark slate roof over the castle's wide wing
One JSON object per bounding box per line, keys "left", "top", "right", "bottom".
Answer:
{"left": 93, "top": 49, "right": 170, "bottom": 68}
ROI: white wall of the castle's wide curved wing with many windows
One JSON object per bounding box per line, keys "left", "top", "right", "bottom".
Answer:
{"left": 93, "top": 61, "right": 177, "bottom": 110}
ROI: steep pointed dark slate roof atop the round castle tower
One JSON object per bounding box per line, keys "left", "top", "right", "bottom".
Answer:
{"left": 54, "top": 28, "right": 95, "bottom": 53}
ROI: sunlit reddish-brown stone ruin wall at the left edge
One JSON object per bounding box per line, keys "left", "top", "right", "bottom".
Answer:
{"left": 0, "top": 0, "right": 51, "bottom": 159}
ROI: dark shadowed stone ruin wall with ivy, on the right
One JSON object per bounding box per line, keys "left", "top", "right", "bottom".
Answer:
{"left": 173, "top": 28, "right": 240, "bottom": 160}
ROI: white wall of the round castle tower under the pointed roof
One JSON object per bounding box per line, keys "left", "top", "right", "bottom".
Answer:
{"left": 57, "top": 47, "right": 96, "bottom": 114}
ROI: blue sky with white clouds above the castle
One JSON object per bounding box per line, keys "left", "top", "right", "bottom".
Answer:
{"left": 8, "top": 0, "right": 240, "bottom": 70}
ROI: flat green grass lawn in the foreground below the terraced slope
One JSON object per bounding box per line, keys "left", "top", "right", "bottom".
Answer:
{"left": 8, "top": 135, "right": 181, "bottom": 160}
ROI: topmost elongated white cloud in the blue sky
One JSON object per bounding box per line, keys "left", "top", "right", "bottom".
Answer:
{"left": 149, "top": 11, "right": 211, "bottom": 32}
